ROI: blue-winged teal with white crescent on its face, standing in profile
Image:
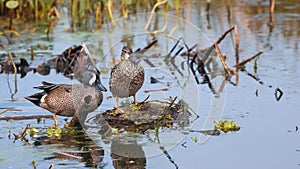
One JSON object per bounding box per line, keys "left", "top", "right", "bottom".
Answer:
{"left": 25, "top": 71, "right": 107, "bottom": 126}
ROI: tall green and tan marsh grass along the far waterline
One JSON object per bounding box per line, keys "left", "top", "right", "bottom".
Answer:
{"left": 0, "top": 0, "right": 184, "bottom": 32}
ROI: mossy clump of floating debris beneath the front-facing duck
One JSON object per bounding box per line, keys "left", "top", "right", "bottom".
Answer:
{"left": 95, "top": 98, "right": 191, "bottom": 132}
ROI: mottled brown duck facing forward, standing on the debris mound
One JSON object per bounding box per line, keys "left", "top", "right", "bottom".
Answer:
{"left": 109, "top": 46, "right": 144, "bottom": 107}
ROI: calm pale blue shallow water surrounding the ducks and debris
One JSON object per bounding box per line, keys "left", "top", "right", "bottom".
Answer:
{"left": 0, "top": 0, "right": 300, "bottom": 168}
